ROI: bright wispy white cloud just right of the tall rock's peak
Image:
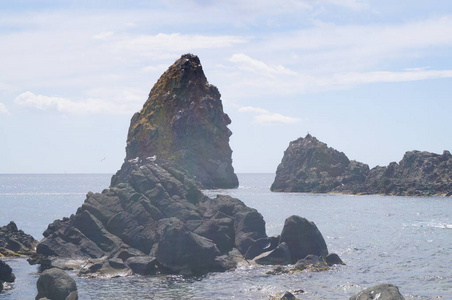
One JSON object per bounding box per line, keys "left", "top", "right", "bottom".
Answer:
{"left": 229, "top": 53, "right": 297, "bottom": 76}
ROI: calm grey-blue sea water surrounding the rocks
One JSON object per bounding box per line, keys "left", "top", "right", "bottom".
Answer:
{"left": 0, "top": 174, "right": 452, "bottom": 300}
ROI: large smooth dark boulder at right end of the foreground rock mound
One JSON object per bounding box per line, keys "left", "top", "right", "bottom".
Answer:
{"left": 280, "top": 216, "right": 328, "bottom": 263}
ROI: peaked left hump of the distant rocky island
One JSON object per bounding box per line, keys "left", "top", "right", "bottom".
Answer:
{"left": 271, "top": 134, "right": 369, "bottom": 193}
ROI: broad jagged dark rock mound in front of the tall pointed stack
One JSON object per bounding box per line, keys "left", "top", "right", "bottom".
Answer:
{"left": 32, "top": 162, "right": 266, "bottom": 276}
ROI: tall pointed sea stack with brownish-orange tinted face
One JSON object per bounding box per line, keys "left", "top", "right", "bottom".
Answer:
{"left": 126, "top": 54, "right": 238, "bottom": 188}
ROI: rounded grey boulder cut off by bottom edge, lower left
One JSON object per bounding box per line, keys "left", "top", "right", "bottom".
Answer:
{"left": 35, "top": 268, "right": 78, "bottom": 300}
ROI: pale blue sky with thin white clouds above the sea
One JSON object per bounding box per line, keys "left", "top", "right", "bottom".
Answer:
{"left": 0, "top": 0, "right": 452, "bottom": 174}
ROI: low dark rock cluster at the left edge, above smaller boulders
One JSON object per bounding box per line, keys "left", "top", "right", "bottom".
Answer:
{"left": 0, "top": 221, "right": 38, "bottom": 256}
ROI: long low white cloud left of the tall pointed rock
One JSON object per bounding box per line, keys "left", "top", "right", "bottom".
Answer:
{"left": 14, "top": 92, "right": 138, "bottom": 114}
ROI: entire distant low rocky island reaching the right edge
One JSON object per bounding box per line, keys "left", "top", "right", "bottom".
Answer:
{"left": 271, "top": 134, "right": 452, "bottom": 196}
